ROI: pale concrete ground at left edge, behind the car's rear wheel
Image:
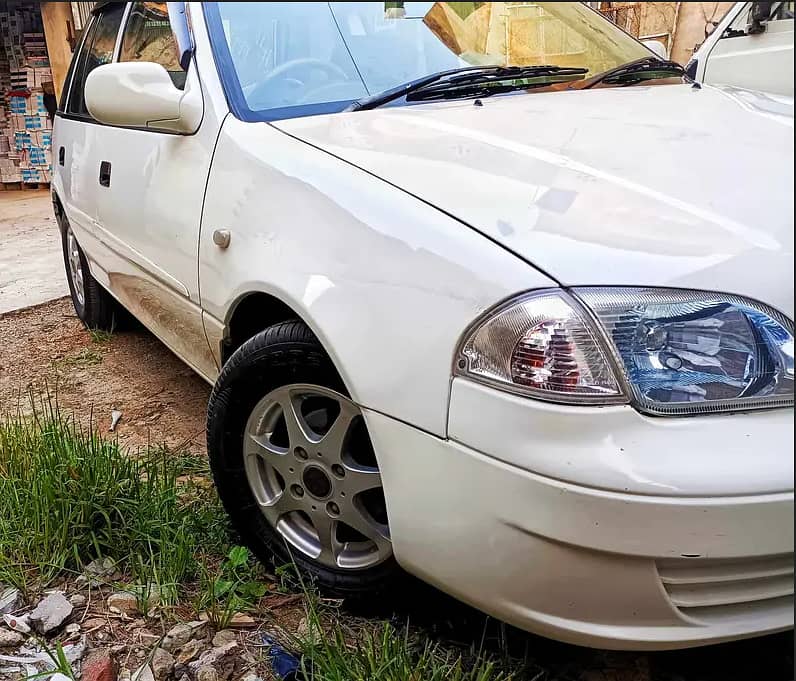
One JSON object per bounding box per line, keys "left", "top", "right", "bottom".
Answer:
{"left": 0, "top": 190, "right": 69, "bottom": 314}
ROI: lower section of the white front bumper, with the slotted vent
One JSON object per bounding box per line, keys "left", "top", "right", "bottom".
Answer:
{"left": 366, "top": 380, "right": 793, "bottom": 649}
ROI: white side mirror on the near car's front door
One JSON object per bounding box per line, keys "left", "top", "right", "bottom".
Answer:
{"left": 85, "top": 62, "right": 202, "bottom": 135}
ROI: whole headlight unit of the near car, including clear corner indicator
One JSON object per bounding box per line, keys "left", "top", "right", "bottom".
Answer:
{"left": 455, "top": 288, "right": 794, "bottom": 415}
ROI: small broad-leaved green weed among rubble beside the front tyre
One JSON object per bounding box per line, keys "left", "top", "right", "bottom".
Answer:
{"left": 196, "top": 546, "right": 267, "bottom": 630}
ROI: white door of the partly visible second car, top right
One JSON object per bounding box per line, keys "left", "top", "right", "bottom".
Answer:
{"left": 704, "top": 2, "right": 794, "bottom": 96}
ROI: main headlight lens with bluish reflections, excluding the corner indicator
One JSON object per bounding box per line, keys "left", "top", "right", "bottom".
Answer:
{"left": 576, "top": 288, "right": 793, "bottom": 414}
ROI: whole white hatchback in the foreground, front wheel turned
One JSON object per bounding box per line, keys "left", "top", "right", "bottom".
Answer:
{"left": 53, "top": 2, "right": 794, "bottom": 649}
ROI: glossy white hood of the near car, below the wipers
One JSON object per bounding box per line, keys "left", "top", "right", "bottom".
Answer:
{"left": 274, "top": 84, "right": 793, "bottom": 318}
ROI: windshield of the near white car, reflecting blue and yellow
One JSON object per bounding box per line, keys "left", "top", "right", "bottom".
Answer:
{"left": 204, "top": 2, "right": 652, "bottom": 120}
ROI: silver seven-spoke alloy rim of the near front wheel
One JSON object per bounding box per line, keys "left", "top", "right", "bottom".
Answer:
{"left": 243, "top": 384, "right": 392, "bottom": 570}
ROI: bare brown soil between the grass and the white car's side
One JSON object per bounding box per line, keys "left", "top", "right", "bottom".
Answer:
{"left": 0, "top": 298, "right": 210, "bottom": 453}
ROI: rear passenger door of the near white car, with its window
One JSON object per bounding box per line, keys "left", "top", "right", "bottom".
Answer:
{"left": 53, "top": 4, "right": 124, "bottom": 269}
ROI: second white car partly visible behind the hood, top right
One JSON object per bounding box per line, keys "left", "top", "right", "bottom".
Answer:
{"left": 686, "top": 2, "right": 794, "bottom": 97}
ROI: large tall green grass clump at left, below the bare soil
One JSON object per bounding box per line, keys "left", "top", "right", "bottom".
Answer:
{"left": 0, "top": 401, "right": 226, "bottom": 601}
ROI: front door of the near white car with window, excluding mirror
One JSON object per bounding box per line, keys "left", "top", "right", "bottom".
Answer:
{"left": 92, "top": 2, "right": 219, "bottom": 380}
